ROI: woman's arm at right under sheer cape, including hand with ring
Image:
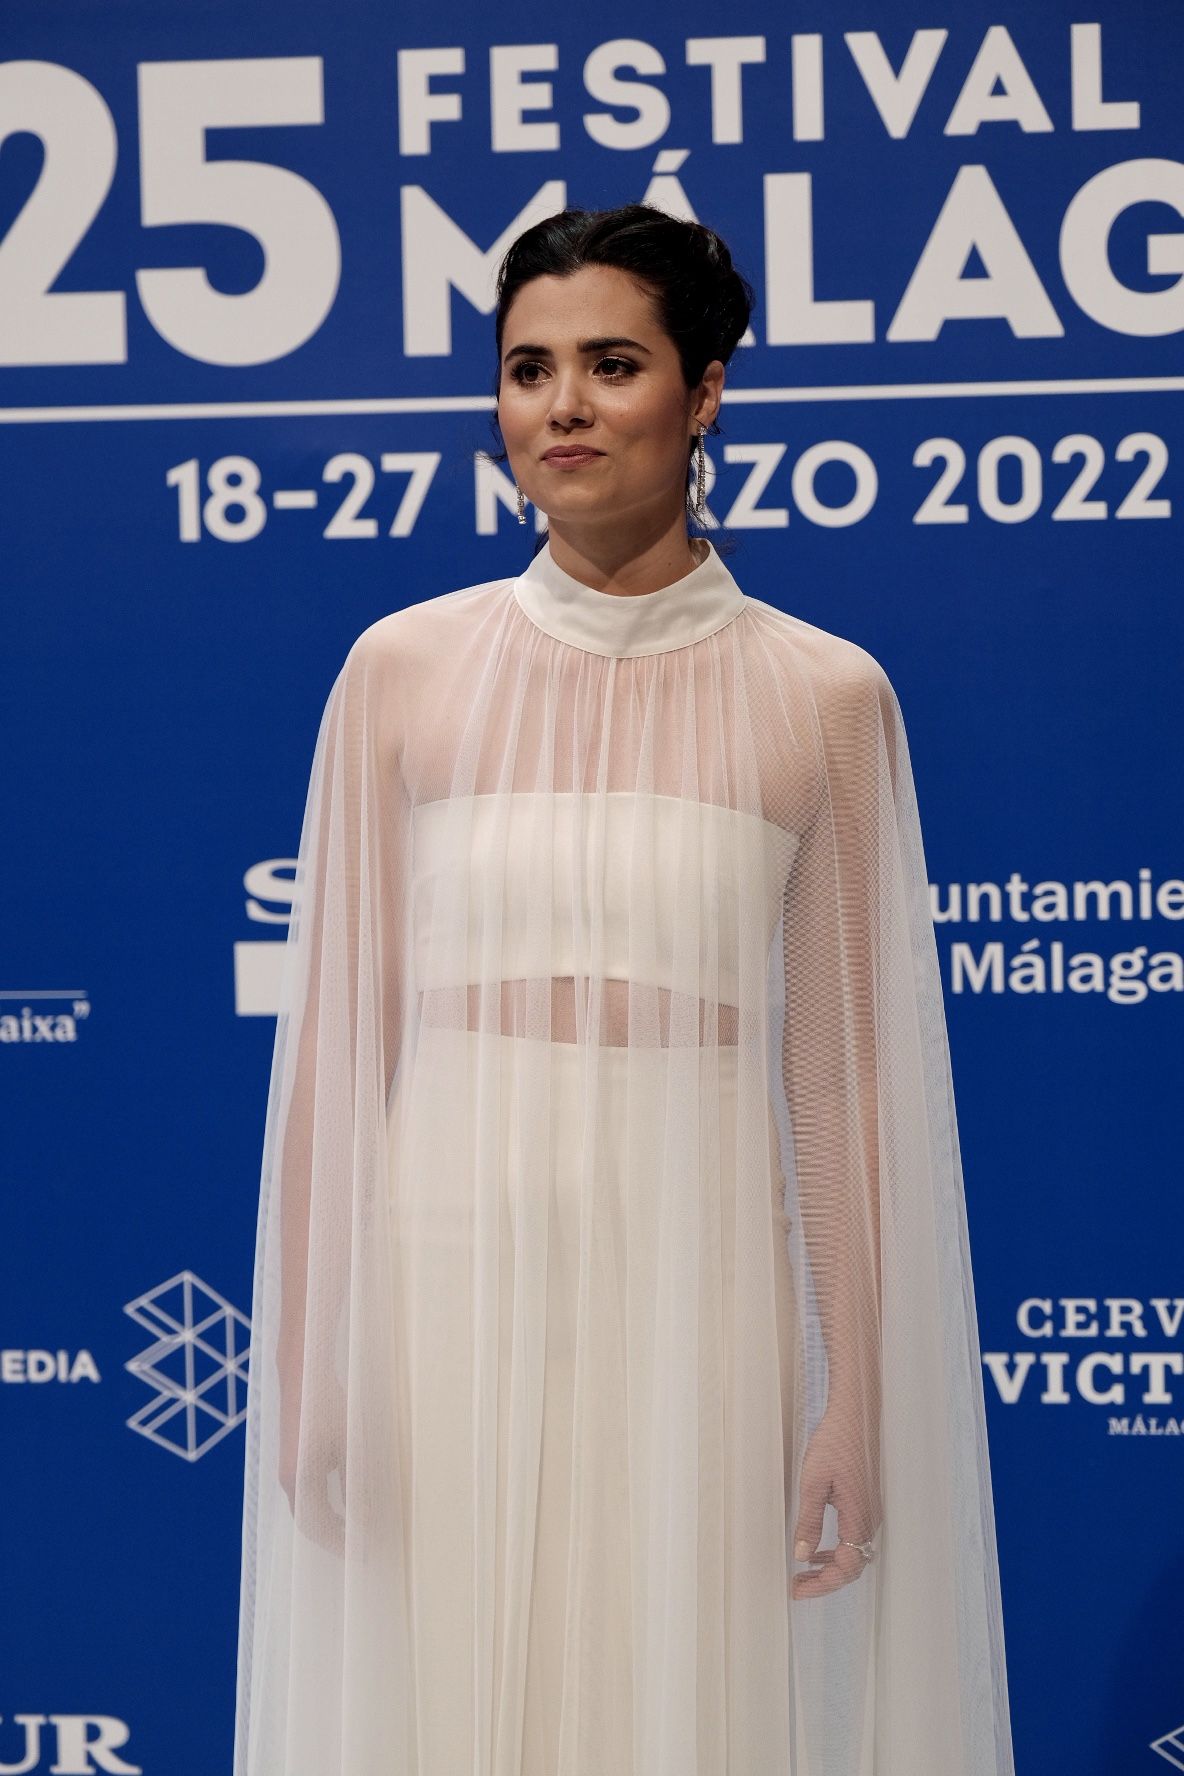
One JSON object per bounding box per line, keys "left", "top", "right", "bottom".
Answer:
{"left": 783, "top": 655, "right": 895, "bottom": 1569}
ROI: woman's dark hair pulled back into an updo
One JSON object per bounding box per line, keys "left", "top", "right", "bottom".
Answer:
{"left": 488, "top": 204, "right": 754, "bottom": 529}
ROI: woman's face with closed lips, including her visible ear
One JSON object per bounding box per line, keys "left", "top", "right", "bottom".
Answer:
{"left": 497, "top": 265, "right": 724, "bottom": 529}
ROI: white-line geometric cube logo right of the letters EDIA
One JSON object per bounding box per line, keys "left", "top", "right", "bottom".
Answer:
{"left": 124, "top": 1270, "right": 250, "bottom": 1462}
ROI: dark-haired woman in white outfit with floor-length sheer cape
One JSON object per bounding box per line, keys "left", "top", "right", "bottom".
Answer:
{"left": 234, "top": 204, "right": 1012, "bottom": 1776}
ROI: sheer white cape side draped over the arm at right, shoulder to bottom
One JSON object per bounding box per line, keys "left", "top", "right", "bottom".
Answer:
{"left": 783, "top": 648, "right": 1012, "bottom": 1776}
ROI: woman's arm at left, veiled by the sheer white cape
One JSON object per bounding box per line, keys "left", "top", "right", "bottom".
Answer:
{"left": 275, "top": 641, "right": 405, "bottom": 1534}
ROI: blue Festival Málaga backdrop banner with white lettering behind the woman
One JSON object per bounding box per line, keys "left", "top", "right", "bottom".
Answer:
{"left": 0, "top": 0, "right": 1184, "bottom": 1776}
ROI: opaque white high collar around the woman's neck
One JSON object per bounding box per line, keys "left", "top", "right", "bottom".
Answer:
{"left": 513, "top": 538, "right": 746, "bottom": 657}
